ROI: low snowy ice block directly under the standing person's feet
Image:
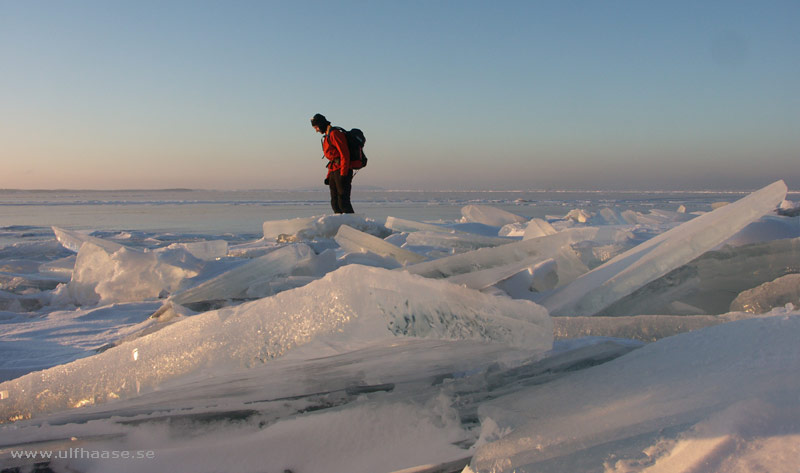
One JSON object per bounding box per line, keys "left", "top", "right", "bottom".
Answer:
{"left": 263, "top": 214, "right": 391, "bottom": 241}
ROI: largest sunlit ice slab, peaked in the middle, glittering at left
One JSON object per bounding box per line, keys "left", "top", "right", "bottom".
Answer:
{"left": 0, "top": 265, "right": 553, "bottom": 420}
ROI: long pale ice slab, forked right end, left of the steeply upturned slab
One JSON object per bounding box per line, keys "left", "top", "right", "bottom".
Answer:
{"left": 405, "top": 227, "right": 598, "bottom": 281}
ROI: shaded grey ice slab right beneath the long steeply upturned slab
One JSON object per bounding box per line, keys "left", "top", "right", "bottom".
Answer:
{"left": 597, "top": 234, "right": 800, "bottom": 316}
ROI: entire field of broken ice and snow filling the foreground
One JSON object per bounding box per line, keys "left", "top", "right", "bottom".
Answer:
{"left": 0, "top": 181, "right": 800, "bottom": 473}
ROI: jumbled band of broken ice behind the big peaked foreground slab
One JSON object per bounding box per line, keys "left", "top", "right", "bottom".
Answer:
{"left": 37, "top": 181, "right": 800, "bottom": 316}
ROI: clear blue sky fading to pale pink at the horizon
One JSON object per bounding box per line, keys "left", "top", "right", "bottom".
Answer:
{"left": 0, "top": 0, "right": 800, "bottom": 190}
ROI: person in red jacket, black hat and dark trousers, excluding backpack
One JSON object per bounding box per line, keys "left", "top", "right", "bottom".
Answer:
{"left": 311, "top": 113, "right": 355, "bottom": 214}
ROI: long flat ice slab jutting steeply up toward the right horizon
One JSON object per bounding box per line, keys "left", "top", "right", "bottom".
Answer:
{"left": 542, "top": 181, "right": 787, "bottom": 315}
